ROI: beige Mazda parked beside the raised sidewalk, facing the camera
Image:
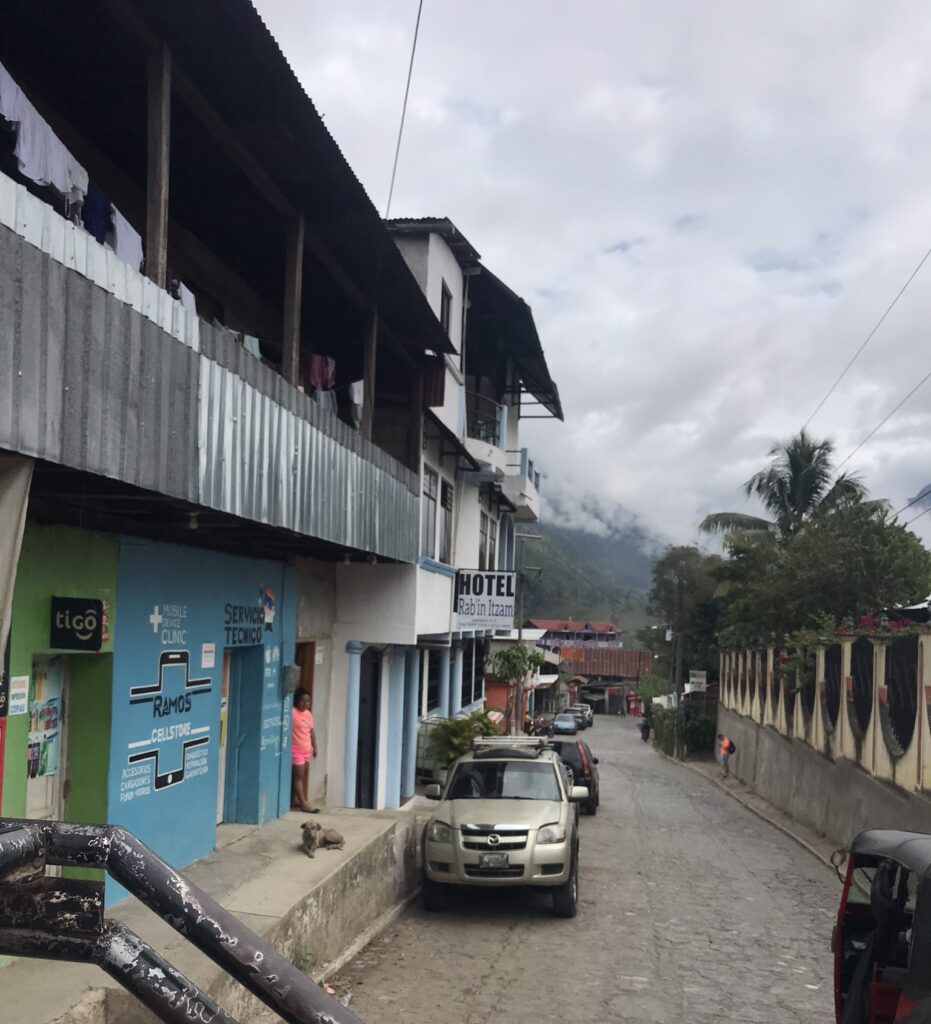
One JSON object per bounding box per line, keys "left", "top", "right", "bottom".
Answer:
{"left": 422, "top": 736, "right": 589, "bottom": 918}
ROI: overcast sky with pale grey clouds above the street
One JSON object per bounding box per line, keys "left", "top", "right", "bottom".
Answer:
{"left": 256, "top": 0, "right": 931, "bottom": 541}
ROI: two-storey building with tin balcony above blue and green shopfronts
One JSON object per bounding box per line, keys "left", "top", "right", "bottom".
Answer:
{"left": 0, "top": 0, "right": 456, "bottom": 896}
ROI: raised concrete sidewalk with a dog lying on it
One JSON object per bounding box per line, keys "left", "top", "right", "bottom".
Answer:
{"left": 0, "top": 799, "right": 426, "bottom": 1024}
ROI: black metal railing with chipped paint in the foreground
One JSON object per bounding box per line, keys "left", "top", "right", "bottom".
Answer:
{"left": 0, "top": 818, "right": 361, "bottom": 1024}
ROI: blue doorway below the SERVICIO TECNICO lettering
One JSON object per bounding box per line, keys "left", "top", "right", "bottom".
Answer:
{"left": 217, "top": 646, "right": 265, "bottom": 824}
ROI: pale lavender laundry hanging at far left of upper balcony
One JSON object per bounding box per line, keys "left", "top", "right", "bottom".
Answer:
{"left": 0, "top": 65, "right": 89, "bottom": 207}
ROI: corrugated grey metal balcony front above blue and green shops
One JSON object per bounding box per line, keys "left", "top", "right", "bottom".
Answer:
{"left": 0, "top": 174, "right": 420, "bottom": 563}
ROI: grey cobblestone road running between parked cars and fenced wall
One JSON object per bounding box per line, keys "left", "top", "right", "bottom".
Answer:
{"left": 338, "top": 719, "right": 839, "bottom": 1024}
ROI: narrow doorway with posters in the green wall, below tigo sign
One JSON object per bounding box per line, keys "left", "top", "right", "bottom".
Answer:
{"left": 26, "top": 654, "right": 70, "bottom": 821}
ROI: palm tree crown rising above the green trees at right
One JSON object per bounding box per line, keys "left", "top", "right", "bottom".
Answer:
{"left": 699, "top": 429, "right": 866, "bottom": 543}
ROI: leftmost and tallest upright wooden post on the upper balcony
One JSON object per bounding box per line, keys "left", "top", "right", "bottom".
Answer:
{"left": 145, "top": 45, "right": 171, "bottom": 288}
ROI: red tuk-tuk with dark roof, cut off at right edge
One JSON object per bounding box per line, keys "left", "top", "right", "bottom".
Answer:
{"left": 832, "top": 828, "right": 931, "bottom": 1024}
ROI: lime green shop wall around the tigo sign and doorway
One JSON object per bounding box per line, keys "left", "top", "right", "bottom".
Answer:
{"left": 0, "top": 523, "right": 120, "bottom": 822}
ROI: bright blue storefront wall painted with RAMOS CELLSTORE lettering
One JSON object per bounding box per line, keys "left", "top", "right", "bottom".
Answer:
{"left": 108, "top": 538, "right": 297, "bottom": 901}
